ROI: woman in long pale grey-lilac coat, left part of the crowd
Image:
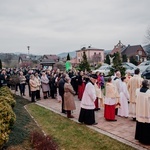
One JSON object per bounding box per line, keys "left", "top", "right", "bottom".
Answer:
{"left": 41, "top": 72, "right": 50, "bottom": 99}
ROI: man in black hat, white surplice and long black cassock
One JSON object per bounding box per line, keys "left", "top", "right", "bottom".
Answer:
{"left": 78, "top": 74, "right": 97, "bottom": 125}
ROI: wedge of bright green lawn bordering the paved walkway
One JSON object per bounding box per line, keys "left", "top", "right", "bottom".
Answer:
{"left": 27, "top": 104, "right": 134, "bottom": 150}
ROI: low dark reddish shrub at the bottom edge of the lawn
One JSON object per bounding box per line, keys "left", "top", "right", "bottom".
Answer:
{"left": 31, "top": 131, "right": 58, "bottom": 150}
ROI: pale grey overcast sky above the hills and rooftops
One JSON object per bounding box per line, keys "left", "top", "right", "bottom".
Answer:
{"left": 0, "top": 0, "right": 150, "bottom": 55}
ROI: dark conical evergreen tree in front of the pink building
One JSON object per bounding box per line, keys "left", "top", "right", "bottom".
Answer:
{"left": 79, "top": 52, "right": 91, "bottom": 71}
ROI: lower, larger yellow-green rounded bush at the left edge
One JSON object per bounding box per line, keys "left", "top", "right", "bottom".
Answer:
{"left": 0, "top": 101, "right": 16, "bottom": 149}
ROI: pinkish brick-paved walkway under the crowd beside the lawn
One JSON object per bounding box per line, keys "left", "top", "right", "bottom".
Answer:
{"left": 15, "top": 89, "right": 150, "bottom": 150}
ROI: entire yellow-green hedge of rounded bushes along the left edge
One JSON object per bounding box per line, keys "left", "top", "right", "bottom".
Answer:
{"left": 0, "top": 87, "right": 16, "bottom": 149}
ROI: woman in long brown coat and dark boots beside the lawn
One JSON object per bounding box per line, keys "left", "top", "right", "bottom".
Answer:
{"left": 64, "top": 76, "right": 76, "bottom": 118}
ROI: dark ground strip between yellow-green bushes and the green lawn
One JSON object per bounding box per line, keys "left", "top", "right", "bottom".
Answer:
{"left": 4, "top": 96, "right": 40, "bottom": 150}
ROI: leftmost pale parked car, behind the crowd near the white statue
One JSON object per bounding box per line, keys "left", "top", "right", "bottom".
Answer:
{"left": 93, "top": 65, "right": 114, "bottom": 76}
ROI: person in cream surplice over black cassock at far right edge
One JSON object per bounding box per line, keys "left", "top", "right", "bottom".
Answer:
{"left": 135, "top": 80, "right": 150, "bottom": 144}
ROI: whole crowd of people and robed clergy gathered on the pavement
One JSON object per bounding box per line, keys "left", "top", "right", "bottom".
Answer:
{"left": 0, "top": 68, "right": 150, "bottom": 144}
